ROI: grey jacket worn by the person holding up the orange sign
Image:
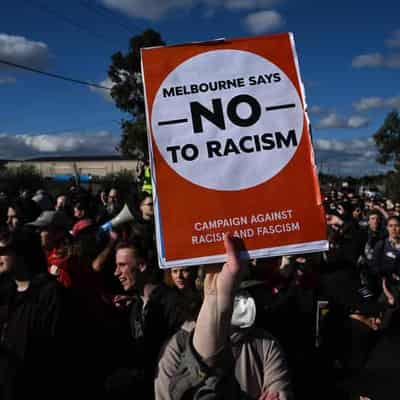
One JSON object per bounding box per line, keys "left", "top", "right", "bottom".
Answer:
{"left": 155, "top": 323, "right": 292, "bottom": 400}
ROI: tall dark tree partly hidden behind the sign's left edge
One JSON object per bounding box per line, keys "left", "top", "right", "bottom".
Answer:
{"left": 108, "top": 29, "right": 165, "bottom": 159}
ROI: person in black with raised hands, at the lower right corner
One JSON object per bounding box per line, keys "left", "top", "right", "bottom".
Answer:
{"left": 321, "top": 271, "right": 398, "bottom": 399}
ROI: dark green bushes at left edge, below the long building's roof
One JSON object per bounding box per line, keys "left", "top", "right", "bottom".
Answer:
{"left": 0, "top": 164, "right": 46, "bottom": 193}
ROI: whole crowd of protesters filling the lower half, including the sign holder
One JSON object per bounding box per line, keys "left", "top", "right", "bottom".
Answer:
{"left": 0, "top": 181, "right": 400, "bottom": 400}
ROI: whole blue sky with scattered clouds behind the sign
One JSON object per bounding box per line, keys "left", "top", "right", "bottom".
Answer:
{"left": 0, "top": 0, "right": 400, "bottom": 175}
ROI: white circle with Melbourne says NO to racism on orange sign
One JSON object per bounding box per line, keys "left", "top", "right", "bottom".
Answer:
{"left": 151, "top": 50, "right": 304, "bottom": 190}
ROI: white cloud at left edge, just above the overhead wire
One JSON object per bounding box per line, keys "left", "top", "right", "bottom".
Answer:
{"left": 0, "top": 33, "right": 49, "bottom": 68}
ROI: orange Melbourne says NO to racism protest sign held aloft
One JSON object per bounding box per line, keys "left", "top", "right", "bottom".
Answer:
{"left": 142, "top": 34, "right": 327, "bottom": 267}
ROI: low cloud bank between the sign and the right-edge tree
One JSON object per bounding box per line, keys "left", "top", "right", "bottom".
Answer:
{"left": 314, "top": 137, "right": 391, "bottom": 176}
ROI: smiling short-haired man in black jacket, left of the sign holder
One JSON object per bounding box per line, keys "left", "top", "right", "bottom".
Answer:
{"left": 106, "top": 241, "right": 184, "bottom": 400}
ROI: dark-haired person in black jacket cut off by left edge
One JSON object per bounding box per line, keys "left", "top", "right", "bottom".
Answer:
{"left": 0, "top": 231, "right": 63, "bottom": 400}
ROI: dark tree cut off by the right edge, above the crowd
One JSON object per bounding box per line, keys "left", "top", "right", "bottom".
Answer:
{"left": 373, "top": 111, "right": 400, "bottom": 171}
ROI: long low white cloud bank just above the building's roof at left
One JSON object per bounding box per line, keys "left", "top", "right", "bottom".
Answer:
{"left": 0, "top": 131, "right": 119, "bottom": 159}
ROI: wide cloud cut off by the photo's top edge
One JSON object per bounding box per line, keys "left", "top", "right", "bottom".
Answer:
{"left": 101, "top": 0, "right": 284, "bottom": 20}
